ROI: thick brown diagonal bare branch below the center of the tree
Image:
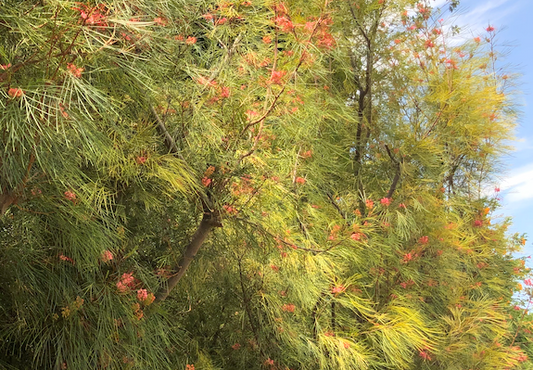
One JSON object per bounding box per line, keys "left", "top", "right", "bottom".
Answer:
{"left": 155, "top": 212, "right": 222, "bottom": 302}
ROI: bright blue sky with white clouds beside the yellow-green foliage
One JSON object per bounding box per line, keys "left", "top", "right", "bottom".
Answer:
{"left": 432, "top": 0, "right": 533, "bottom": 256}
